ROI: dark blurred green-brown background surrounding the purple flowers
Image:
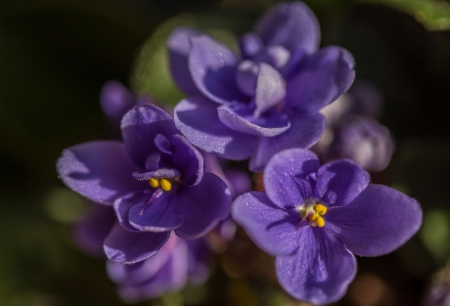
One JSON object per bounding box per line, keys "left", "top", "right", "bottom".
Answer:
{"left": 0, "top": 0, "right": 450, "bottom": 306}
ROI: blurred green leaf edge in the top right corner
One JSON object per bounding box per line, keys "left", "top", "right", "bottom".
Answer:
{"left": 357, "top": 0, "right": 450, "bottom": 31}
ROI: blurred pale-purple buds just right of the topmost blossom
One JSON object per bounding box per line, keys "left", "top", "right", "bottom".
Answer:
{"left": 312, "top": 82, "right": 394, "bottom": 171}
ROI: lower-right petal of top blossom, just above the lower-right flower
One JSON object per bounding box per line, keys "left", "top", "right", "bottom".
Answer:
{"left": 250, "top": 114, "right": 325, "bottom": 172}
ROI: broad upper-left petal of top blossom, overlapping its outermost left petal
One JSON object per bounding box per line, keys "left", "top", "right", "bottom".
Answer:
{"left": 189, "top": 35, "right": 246, "bottom": 103}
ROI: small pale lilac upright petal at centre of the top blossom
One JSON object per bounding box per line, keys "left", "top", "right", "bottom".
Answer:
{"left": 254, "top": 63, "right": 286, "bottom": 117}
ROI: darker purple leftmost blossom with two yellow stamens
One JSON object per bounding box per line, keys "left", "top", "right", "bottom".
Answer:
{"left": 57, "top": 105, "right": 231, "bottom": 263}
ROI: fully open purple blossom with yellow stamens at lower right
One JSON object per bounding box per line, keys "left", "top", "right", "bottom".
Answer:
{"left": 232, "top": 149, "right": 422, "bottom": 304}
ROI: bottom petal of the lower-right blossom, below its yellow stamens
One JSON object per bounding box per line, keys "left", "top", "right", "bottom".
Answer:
{"left": 275, "top": 227, "right": 356, "bottom": 305}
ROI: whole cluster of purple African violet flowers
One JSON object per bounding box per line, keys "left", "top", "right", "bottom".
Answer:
{"left": 57, "top": 2, "right": 422, "bottom": 304}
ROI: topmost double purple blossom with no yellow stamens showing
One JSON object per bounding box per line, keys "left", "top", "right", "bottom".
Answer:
{"left": 168, "top": 2, "right": 355, "bottom": 171}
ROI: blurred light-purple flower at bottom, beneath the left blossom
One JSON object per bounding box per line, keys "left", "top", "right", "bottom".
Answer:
{"left": 107, "top": 234, "right": 211, "bottom": 303}
